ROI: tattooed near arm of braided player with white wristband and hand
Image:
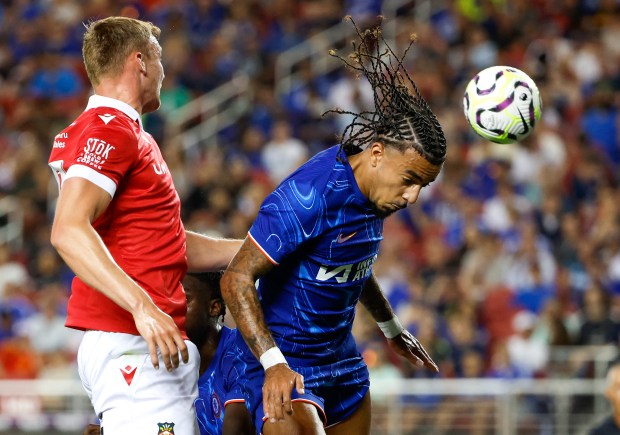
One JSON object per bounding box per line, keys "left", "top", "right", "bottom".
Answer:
{"left": 220, "top": 238, "right": 304, "bottom": 422}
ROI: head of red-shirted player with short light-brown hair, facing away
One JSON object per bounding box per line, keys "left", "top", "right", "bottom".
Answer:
{"left": 82, "top": 17, "right": 164, "bottom": 113}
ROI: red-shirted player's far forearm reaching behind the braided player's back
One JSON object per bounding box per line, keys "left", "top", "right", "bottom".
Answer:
{"left": 185, "top": 231, "right": 243, "bottom": 272}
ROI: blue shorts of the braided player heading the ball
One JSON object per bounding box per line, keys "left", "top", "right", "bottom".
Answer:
{"left": 232, "top": 343, "right": 370, "bottom": 433}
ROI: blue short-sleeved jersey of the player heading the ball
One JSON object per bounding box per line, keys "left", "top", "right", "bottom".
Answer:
{"left": 249, "top": 146, "right": 383, "bottom": 367}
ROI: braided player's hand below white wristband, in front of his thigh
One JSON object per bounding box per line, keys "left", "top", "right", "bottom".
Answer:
{"left": 263, "top": 364, "right": 304, "bottom": 423}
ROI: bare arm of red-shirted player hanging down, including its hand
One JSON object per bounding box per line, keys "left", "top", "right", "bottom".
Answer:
{"left": 51, "top": 177, "right": 189, "bottom": 370}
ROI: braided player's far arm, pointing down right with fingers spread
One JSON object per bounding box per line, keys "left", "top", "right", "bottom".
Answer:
{"left": 360, "top": 274, "right": 439, "bottom": 372}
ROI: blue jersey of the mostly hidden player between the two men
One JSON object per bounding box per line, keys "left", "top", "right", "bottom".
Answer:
{"left": 195, "top": 326, "right": 244, "bottom": 435}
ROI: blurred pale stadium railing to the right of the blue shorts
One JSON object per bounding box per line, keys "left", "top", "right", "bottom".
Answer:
{"left": 372, "top": 379, "right": 608, "bottom": 435}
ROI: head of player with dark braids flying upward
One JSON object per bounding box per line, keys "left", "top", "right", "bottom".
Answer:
{"left": 330, "top": 17, "right": 446, "bottom": 216}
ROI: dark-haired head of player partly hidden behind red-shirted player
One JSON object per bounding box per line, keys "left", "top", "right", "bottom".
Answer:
{"left": 183, "top": 272, "right": 226, "bottom": 346}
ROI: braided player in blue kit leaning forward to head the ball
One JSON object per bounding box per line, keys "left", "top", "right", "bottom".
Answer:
{"left": 222, "top": 17, "right": 446, "bottom": 435}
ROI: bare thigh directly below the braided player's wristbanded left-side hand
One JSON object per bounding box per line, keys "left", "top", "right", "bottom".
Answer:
{"left": 263, "top": 402, "right": 325, "bottom": 435}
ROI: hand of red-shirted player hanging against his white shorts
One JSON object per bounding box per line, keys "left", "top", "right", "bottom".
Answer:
{"left": 133, "top": 304, "right": 189, "bottom": 372}
